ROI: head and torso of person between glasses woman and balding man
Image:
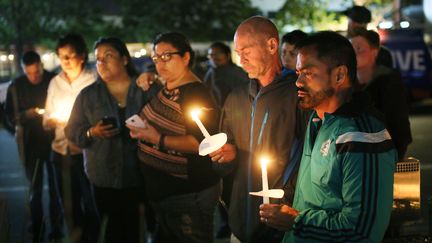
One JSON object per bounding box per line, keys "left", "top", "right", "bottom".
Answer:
{"left": 203, "top": 42, "right": 249, "bottom": 107}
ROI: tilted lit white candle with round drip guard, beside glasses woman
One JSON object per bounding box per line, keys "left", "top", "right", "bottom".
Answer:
{"left": 191, "top": 109, "right": 227, "bottom": 156}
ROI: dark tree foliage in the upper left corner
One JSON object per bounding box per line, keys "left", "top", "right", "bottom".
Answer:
{"left": 0, "top": 0, "right": 105, "bottom": 75}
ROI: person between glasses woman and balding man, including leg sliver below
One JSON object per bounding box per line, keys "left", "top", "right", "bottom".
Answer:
{"left": 203, "top": 42, "right": 249, "bottom": 238}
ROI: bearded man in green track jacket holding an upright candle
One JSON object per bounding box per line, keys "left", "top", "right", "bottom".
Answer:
{"left": 260, "top": 31, "right": 397, "bottom": 242}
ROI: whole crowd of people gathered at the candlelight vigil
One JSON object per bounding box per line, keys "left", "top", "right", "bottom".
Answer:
{"left": 5, "top": 6, "right": 412, "bottom": 242}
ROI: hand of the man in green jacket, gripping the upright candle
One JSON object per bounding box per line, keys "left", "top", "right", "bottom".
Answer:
{"left": 260, "top": 204, "right": 299, "bottom": 231}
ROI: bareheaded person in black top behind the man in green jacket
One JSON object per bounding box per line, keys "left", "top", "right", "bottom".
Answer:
{"left": 350, "top": 27, "right": 412, "bottom": 161}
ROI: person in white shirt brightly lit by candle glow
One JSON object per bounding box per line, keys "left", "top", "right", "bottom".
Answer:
{"left": 43, "top": 34, "right": 98, "bottom": 242}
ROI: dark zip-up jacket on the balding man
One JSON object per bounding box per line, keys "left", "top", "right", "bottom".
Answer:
{"left": 222, "top": 74, "right": 309, "bottom": 242}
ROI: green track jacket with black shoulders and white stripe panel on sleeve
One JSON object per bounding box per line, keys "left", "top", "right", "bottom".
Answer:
{"left": 283, "top": 94, "right": 397, "bottom": 242}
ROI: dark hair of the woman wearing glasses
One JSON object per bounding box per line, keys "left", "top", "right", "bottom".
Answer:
{"left": 153, "top": 32, "right": 195, "bottom": 68}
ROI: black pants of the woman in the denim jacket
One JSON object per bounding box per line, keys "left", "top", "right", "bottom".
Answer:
{"left": 94, "top": 186, "right": 140, "bottom": 243}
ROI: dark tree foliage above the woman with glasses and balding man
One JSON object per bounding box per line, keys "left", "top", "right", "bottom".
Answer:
{"left": 118, "top": 0, "right": 258, "bottom": 41}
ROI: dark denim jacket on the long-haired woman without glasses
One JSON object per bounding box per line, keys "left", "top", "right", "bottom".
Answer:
{"left": 65, "top": 77, "right": 155, "bottom": 189}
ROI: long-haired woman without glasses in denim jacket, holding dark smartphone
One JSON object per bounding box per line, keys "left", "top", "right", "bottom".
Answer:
{"left": 65, "top": 37, "right": 157, "bottom": 242}
